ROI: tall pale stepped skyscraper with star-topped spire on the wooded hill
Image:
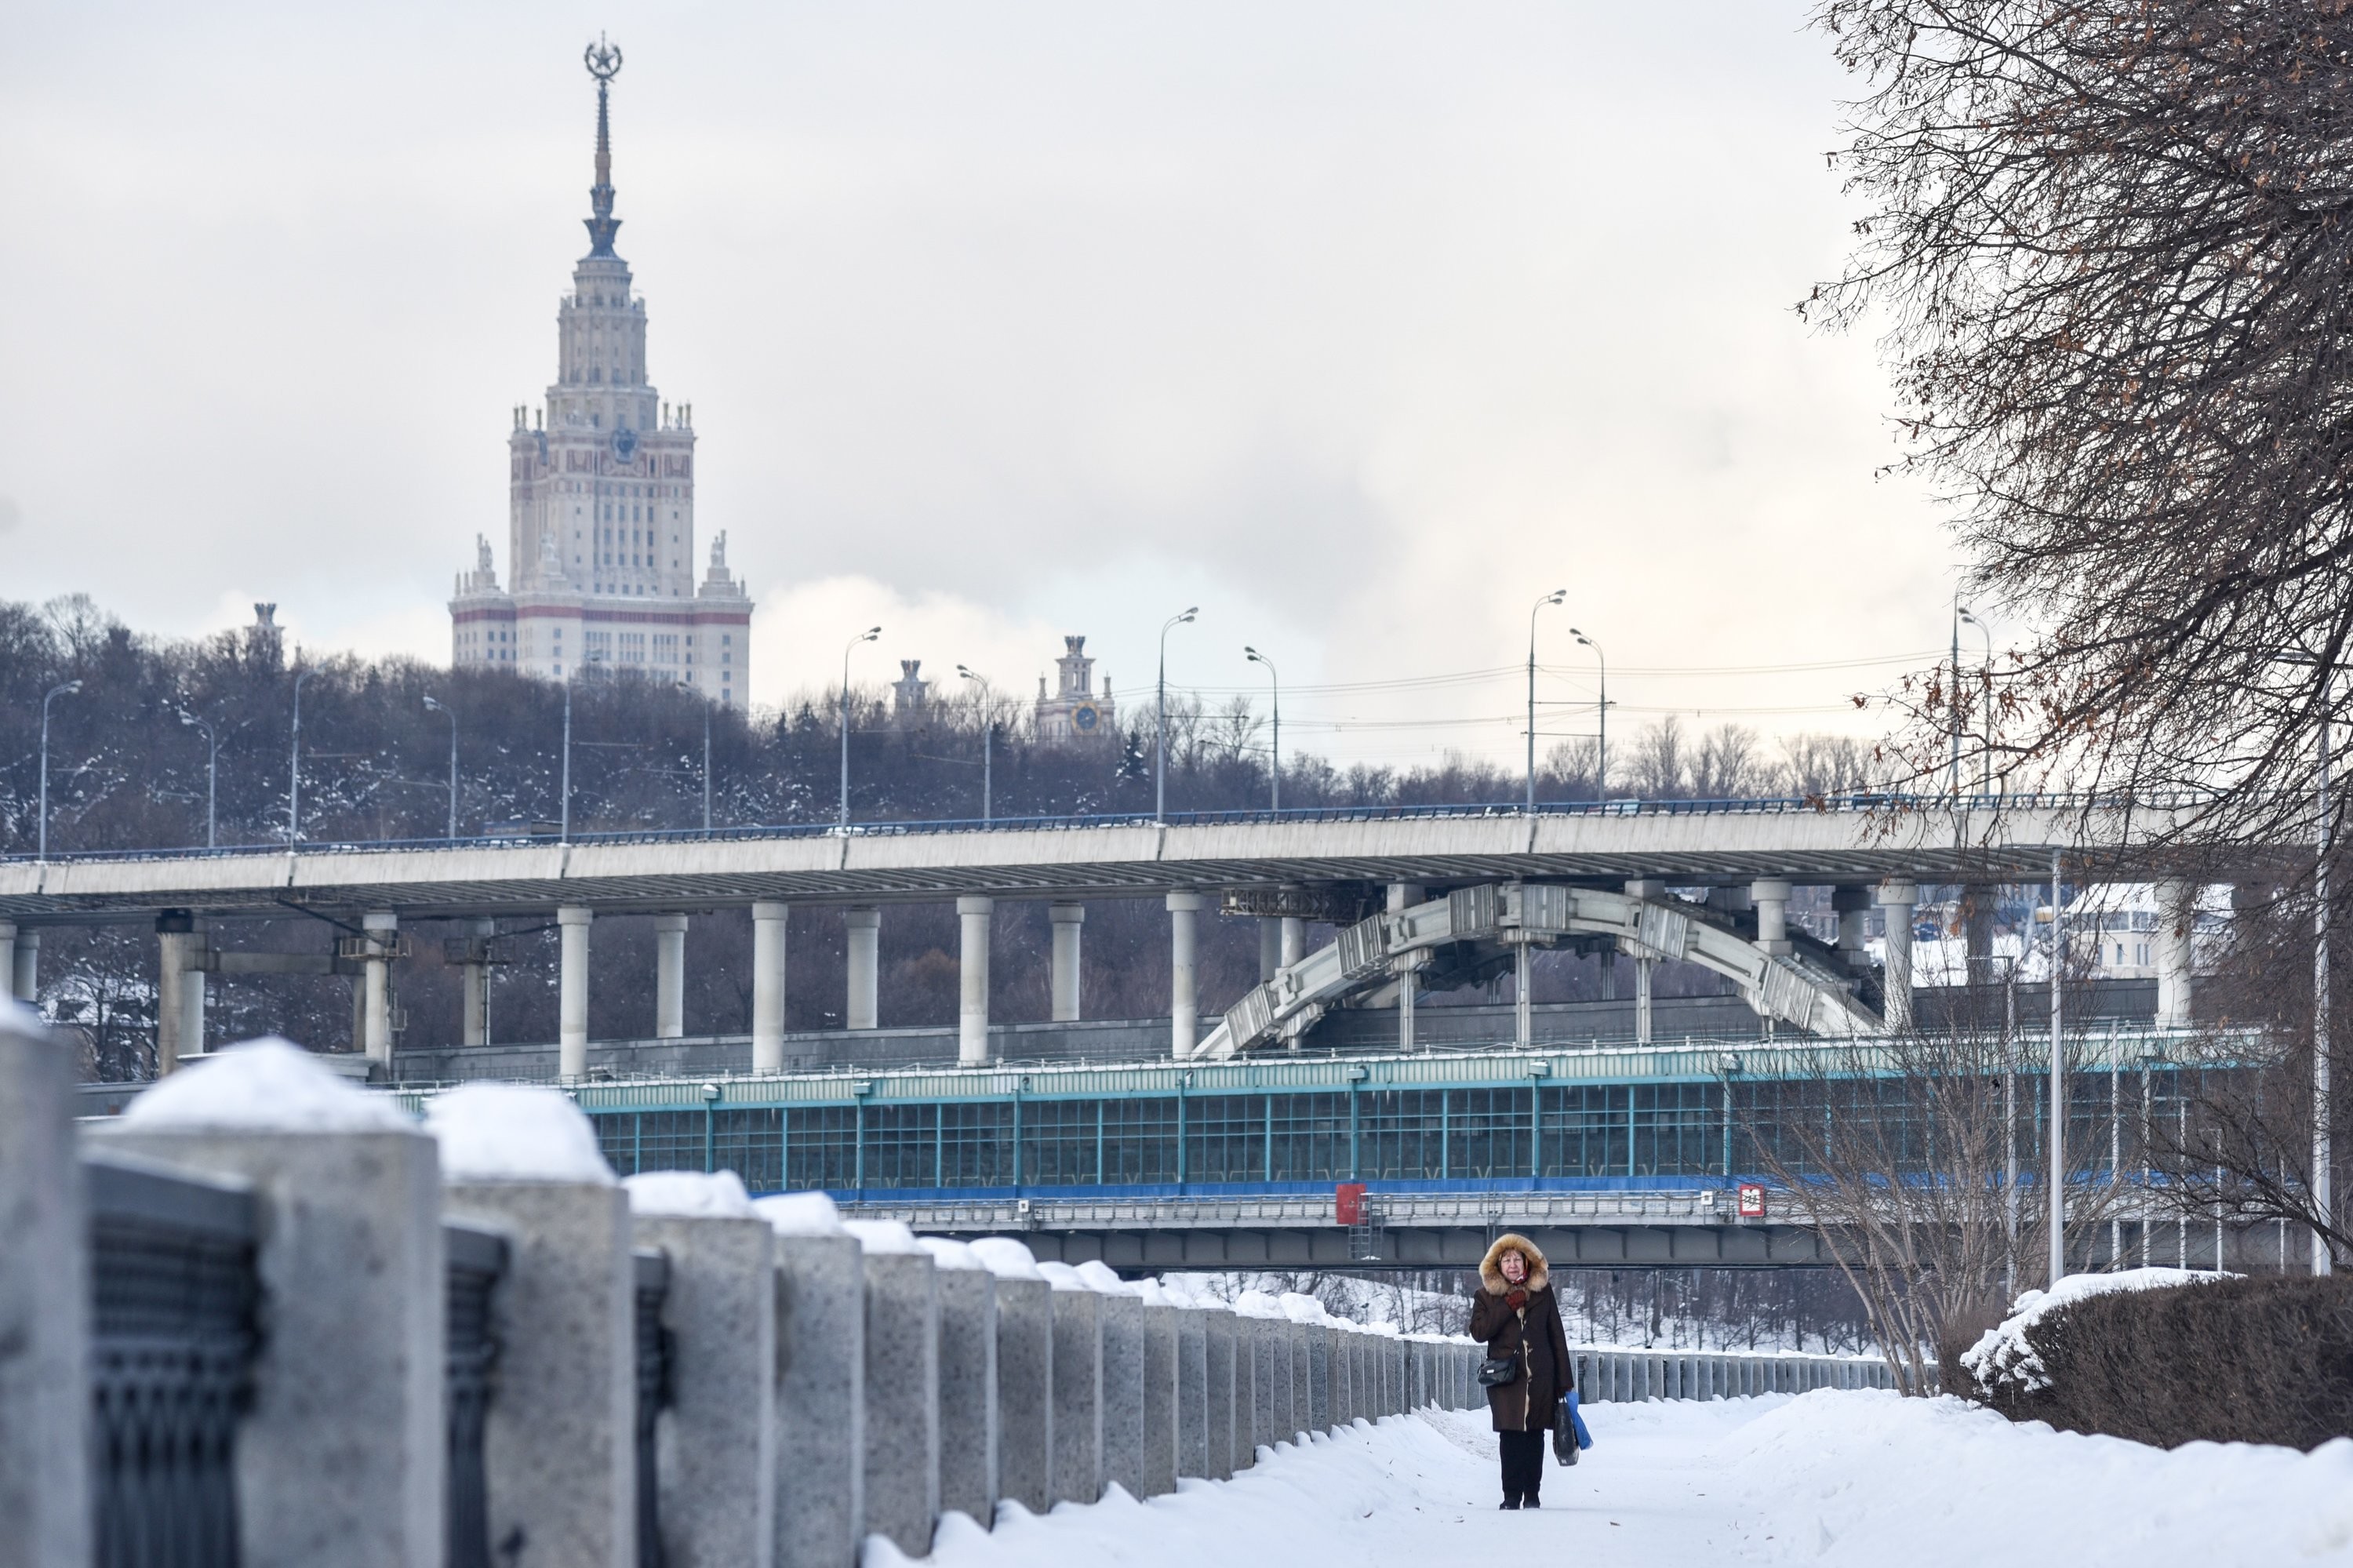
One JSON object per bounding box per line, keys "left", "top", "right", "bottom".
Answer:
{"left": 449, "top": 38, "right": 751, "bottom": 706}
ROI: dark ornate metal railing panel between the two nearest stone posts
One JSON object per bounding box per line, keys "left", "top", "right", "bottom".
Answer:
{"left": 86, "top": 1156, "right": 256, "bottom": 1568}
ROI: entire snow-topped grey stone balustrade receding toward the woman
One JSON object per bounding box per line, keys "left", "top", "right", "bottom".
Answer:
{"left": 0, "top": 1031, "right": 1544, "bottom": 1568}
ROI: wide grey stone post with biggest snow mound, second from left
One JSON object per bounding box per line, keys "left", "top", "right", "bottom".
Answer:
{"left": 102, "top": 1041, "right": 449, "bottom": 1568}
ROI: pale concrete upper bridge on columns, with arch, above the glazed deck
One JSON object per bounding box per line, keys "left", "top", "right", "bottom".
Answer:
{"left": 0, "top": 796, "right": 2278, "bottom": 1079}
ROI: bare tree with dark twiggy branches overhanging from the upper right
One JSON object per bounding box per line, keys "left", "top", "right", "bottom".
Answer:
{"left": 1802, "top": 0, "right": 2353, "bottom": 836}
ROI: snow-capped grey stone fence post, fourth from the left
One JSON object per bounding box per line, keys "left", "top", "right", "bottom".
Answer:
{"left": 621, "top": 1170, "right": 776, "bottom": 1563}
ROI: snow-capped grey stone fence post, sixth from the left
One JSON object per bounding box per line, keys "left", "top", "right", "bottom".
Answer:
{"left": 842, "top": 1220, "right": 939, "bottom": 1556}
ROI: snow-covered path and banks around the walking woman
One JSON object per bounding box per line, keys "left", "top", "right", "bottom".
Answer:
{"left": 864, "top": 1392, "right": 2353, "bottom": 1568}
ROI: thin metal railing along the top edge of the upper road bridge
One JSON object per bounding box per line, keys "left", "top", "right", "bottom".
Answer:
{"left": 0, "top": 791, "right": 2155, "bottom": 864}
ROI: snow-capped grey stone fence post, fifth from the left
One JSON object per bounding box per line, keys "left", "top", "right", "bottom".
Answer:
{"left": 753, "top": 1191, "right": 866, "bottom": 1568}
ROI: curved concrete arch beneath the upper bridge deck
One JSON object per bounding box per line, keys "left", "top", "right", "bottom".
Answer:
{"left": 1186, "top": 883, "right": 1887, "bottom": 1062}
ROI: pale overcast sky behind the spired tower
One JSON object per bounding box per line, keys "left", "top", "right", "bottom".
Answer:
{"left": 0, "top": 0, "right": 1951, "bottom": 762}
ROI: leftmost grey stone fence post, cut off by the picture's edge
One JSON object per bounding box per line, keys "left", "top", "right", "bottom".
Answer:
{"left": 0, "top": 984, "right": 89, "bottom": 1568}
